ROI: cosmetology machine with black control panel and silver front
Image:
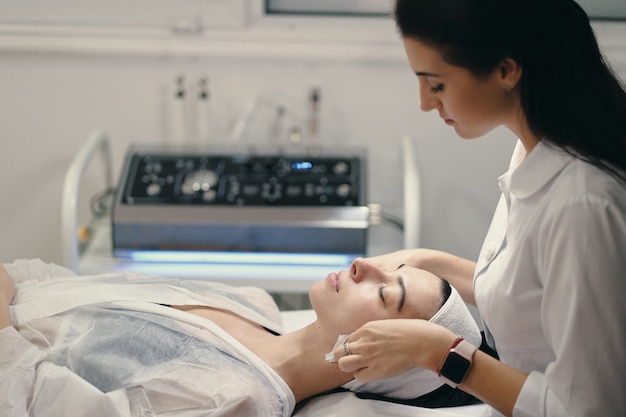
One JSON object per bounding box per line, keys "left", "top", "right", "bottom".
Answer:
{"left": 112, "top": 146, "right": 369, "bottom": 262}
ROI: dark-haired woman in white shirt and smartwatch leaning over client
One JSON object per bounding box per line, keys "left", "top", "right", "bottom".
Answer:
{"left": 336, "top": 0, "right": 626, "bottom": 416}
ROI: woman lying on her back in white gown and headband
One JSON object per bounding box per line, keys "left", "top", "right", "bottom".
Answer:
{"left": 0, "top": 259, "right": 480, "bottom": 417}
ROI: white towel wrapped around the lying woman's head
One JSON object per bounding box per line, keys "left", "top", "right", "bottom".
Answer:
{"left": 343, "top": 287, "right": 481, "bottom": 400}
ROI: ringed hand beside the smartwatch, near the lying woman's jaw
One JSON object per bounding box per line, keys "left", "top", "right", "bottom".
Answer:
{"left": 334, "top": 319, "right": 456, "bottom": 382}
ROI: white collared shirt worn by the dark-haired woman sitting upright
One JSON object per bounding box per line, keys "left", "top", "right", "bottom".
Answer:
{"left": 474, "top": 142, "right": 626, "bottom": 417}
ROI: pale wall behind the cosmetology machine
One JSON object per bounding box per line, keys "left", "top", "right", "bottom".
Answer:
{"left": 0, "top": 16, "right": 626, "bottom": 263}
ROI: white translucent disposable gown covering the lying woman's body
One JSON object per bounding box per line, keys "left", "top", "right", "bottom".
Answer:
{"left": 0, "top": 261, "right": 295, "bottom": 417}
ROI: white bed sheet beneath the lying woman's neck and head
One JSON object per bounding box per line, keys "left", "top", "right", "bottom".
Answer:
{"left": 281, "top": 310, "right": 502, "bottom": 417}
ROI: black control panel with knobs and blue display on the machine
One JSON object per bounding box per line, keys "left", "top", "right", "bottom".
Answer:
{"left": 120, "top": 152, "right": 366, "bottom": 206}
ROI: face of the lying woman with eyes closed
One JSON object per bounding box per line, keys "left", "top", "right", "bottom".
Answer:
{"left": 309, "top": 258, "right": 442, "bottom": 335}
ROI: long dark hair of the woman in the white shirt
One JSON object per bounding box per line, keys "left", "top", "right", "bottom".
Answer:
{"left": 395, "top": 0, "right": 626, "bottom": 181}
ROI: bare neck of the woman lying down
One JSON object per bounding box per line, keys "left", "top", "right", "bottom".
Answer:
{"left": 254, "top": 322, "right": 353, "bottom": 401}
